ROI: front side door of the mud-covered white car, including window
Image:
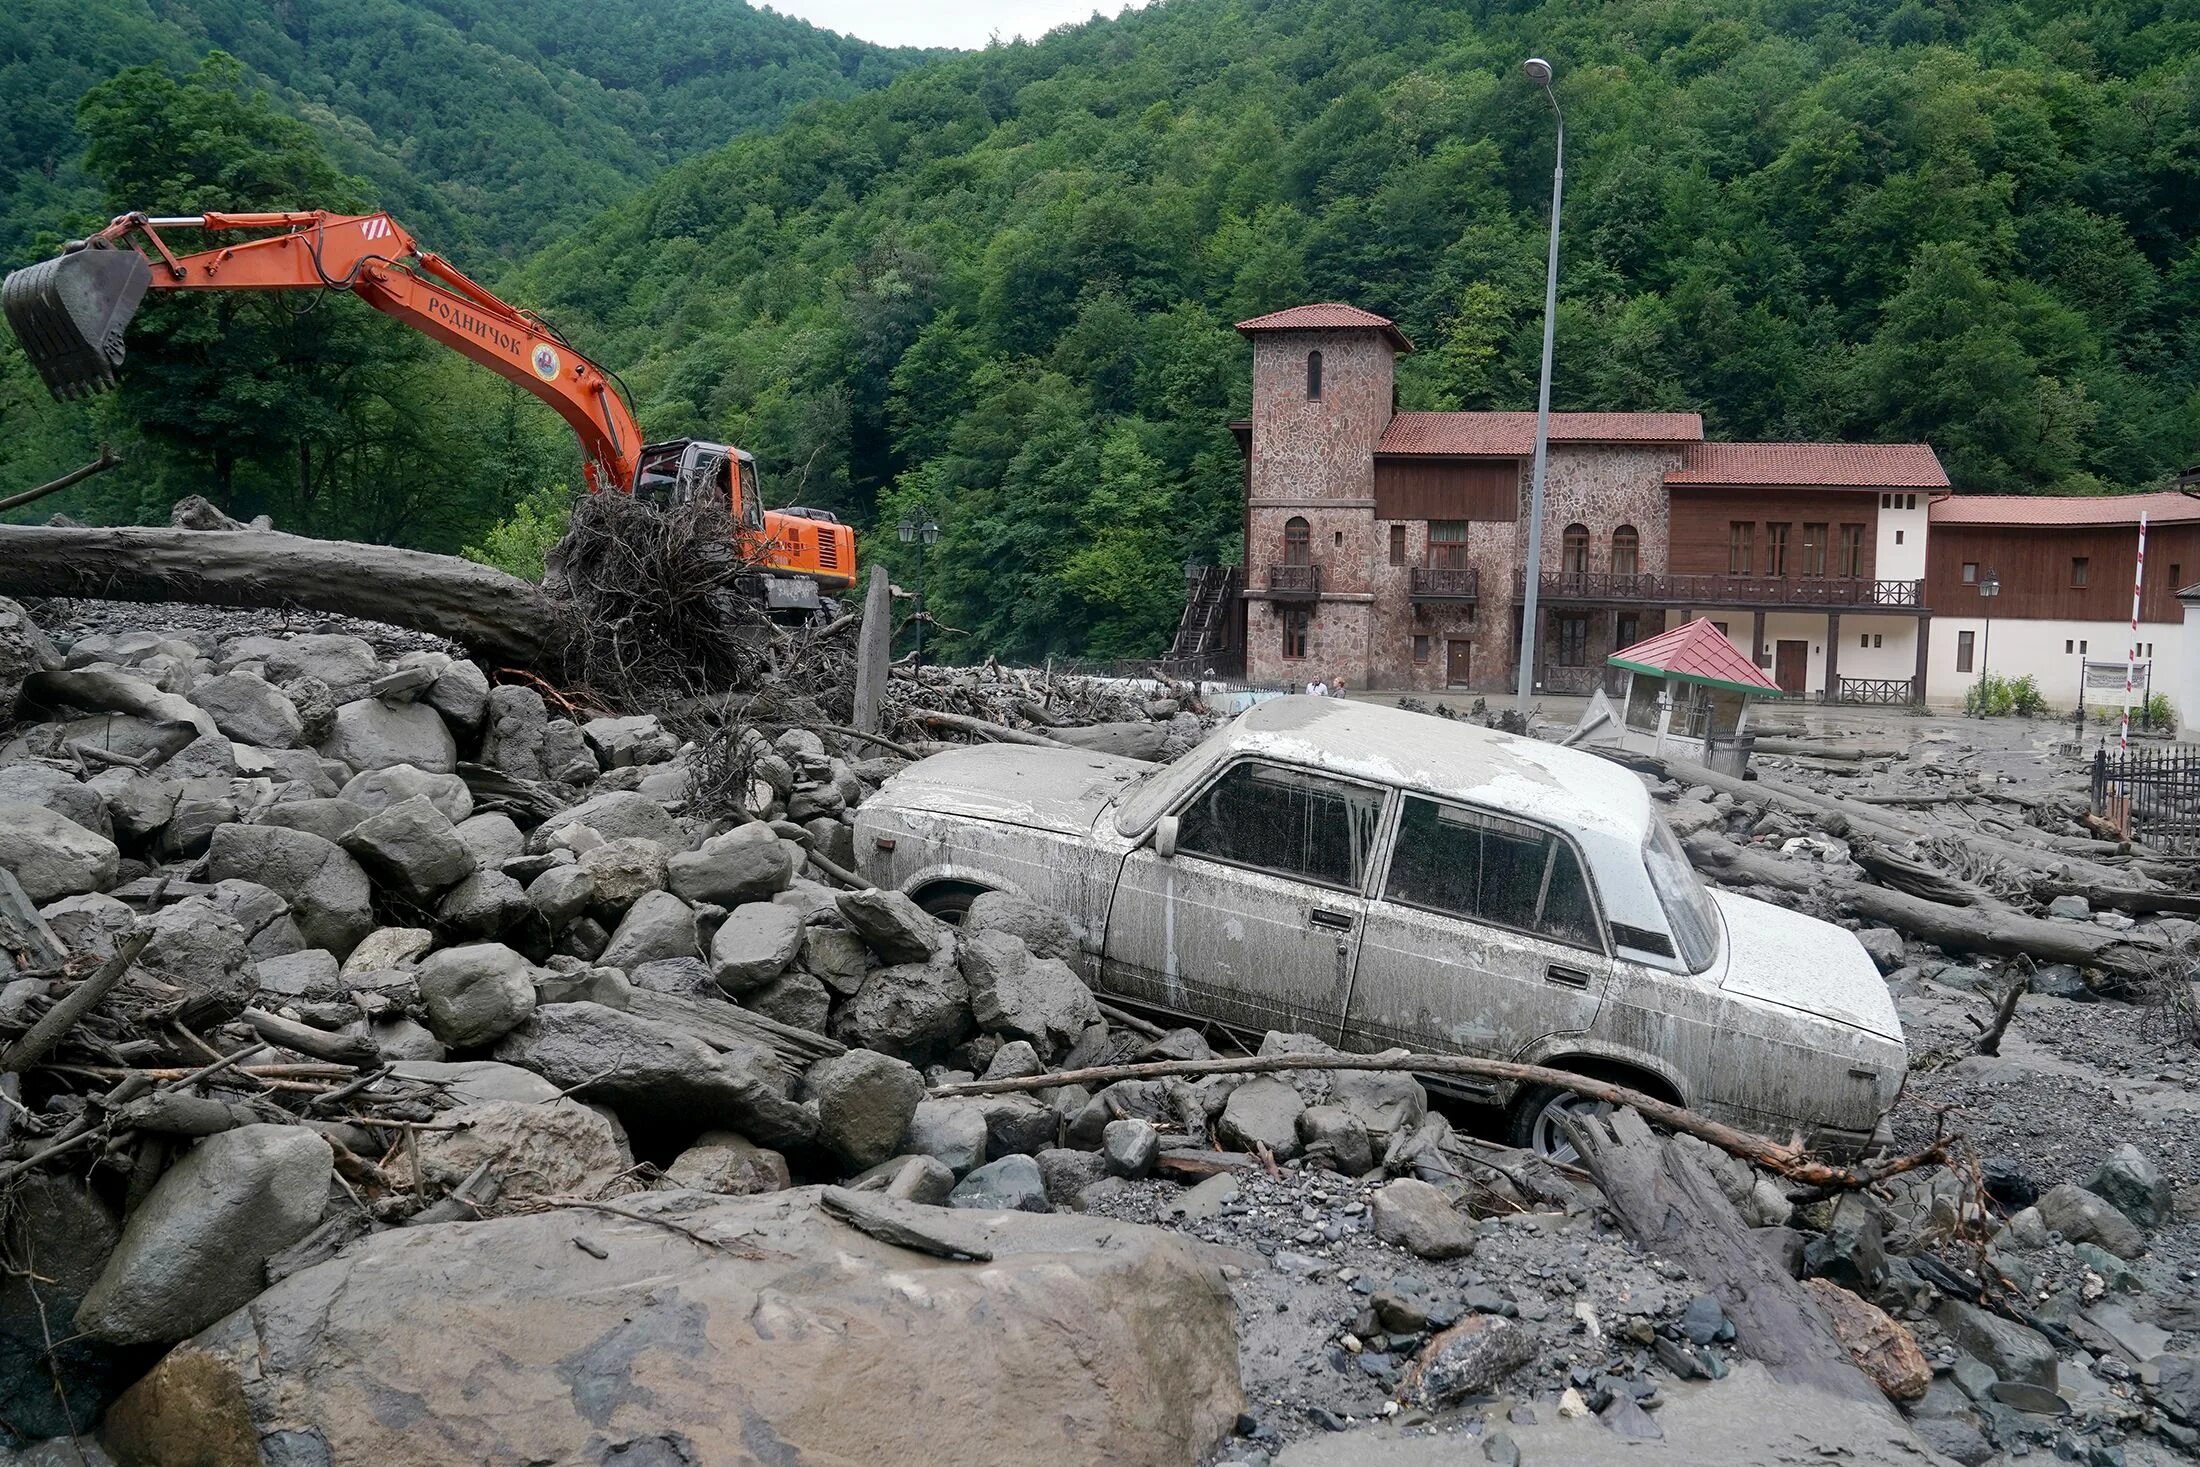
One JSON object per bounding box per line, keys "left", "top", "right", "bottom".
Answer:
{"left": 1102, "top": 759, "right": 1388, "bottom": 1043}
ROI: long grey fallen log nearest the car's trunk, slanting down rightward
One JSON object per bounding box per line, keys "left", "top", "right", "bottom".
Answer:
{"left": 1683, "top": 831, "right": 2158, "bottom": 977}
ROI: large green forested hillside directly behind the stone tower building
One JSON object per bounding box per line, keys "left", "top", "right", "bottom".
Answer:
{"left": 521, "top": 0, "right": 2200, "bottom": 655}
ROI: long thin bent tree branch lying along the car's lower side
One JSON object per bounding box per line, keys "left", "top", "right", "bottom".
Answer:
{"left": 931, "top": 1054, "right": 1954, "bottom": 1188}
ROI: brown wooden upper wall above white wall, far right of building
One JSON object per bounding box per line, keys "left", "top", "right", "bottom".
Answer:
{"left": 1925, "top": 521, "right": 2200, "bottom": 622}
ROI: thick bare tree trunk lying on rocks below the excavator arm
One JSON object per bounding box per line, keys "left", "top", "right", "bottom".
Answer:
{"left": 0, "top": 526, "right": 565, "bottom": 666}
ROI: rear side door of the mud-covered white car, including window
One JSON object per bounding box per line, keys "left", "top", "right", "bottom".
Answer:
{"left": 1344, "top": 794, "right": 1610, "bottom": 1060}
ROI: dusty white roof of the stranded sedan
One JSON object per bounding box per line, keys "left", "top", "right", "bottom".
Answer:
{"left": 1221, "top": 693, "right": 1652, "bottom": 845}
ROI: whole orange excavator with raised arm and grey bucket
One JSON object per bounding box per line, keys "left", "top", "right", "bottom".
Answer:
{"left": 0, "top": 209, "right": 856, "bottom": 614}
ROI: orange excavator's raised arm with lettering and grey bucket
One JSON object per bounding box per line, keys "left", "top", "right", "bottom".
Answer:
{"left": 0, "top": 209, "right": 642, "bottom": 490}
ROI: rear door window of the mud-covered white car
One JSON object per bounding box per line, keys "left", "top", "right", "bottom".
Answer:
{"left": 1384, "top": 794, "right": 1604, "bottom": 948}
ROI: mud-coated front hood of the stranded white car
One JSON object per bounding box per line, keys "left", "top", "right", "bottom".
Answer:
{"left": 867, "top": 743, "right": 1155, "bottom": 834}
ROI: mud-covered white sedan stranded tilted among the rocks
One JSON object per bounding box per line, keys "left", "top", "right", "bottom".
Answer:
{"left": 856, "top": 697, "right": 1910, "bottom": 1155}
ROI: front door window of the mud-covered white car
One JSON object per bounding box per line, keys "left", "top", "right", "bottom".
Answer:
{"left": 1177, "top": 763, "right": 1384, "bottom": 891}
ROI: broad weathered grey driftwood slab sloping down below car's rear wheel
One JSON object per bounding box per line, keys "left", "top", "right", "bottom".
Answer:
{"left": 1566, "top": 1111, "right": 1903, "bottom": 1407}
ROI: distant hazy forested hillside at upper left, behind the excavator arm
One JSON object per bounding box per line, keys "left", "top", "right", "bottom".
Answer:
{"left": 0, "top": 0, "right": 924, "bottom": 262}
